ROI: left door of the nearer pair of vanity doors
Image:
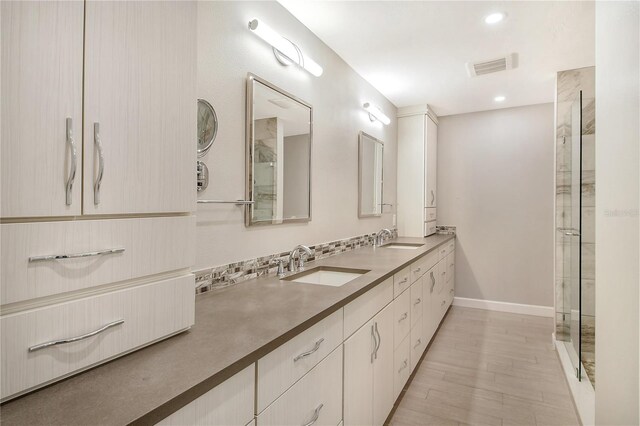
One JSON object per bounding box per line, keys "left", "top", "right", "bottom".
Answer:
{"left": 344, "top": 320, "right": 376, "bottom": 426}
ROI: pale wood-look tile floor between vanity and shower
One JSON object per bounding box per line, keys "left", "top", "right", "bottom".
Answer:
{"left": 389, "top": 306, "right": 580, "bottom": 426}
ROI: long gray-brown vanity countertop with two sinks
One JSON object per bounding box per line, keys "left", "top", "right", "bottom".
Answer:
{"left": 0, "top": 235, "right": 454, "bottom": 425}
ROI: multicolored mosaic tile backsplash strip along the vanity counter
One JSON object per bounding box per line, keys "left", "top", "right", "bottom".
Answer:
{"left": 196, "top": 228, "right": 398, "bottom": 294}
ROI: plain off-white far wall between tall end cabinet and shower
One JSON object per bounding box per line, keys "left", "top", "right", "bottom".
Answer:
{"left": 437, "top": 104, "right": 555, "bottom": 306}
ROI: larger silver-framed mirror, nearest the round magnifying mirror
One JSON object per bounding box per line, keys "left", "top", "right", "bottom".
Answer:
{"left": 245, "top": 74, "right": 313, "bottom": 226}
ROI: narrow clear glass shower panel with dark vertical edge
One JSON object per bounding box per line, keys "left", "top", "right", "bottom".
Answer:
{"left": 560, "top": 91, "right": 582, "bottom": 380}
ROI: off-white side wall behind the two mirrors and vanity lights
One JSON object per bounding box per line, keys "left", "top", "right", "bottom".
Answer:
{"left": 196, "top": 2, "right": 397, "bottom": 269}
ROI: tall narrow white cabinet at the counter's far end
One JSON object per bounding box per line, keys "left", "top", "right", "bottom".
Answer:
{"left": 397, "top": 105, "right": 438, "bottom": 237}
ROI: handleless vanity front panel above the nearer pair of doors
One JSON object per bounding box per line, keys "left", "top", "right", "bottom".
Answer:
{"left": 344, "top": 277, "right": 393, "bottom": 340}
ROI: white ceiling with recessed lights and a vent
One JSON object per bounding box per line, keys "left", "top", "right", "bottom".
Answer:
{"left": 279, "top": 0, "right": 595, "bottom": 115}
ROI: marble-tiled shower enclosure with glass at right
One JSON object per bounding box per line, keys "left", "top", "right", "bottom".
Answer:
{"left": 556, "top": 68, "right": 595, "bottom": 386}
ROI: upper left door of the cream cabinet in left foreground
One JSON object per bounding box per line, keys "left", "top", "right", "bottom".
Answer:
{"left": 0, "top": 1, "right": 84, "bottom": 217}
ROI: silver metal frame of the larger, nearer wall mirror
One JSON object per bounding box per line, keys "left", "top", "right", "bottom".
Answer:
{"left": 244, "top": 73, "right": 313, "bottom": 227}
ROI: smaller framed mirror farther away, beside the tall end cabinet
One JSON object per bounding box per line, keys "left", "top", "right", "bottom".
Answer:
{"left": 358, "top": 132, "right": 384, "bottom": 217}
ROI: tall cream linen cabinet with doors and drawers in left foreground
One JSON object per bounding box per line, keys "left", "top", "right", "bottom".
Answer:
{"left": 0, "top": 1, "right": 196, "bottom": 401}
